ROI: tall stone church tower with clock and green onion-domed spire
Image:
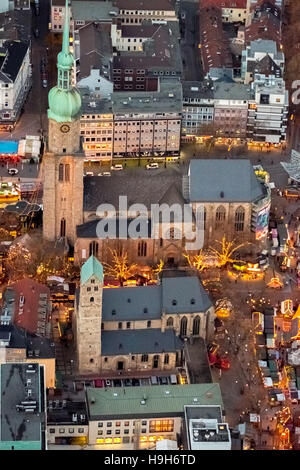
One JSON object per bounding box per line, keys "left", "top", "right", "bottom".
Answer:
{"left": 43, "top": 0, "right": 84, "bottom": 245}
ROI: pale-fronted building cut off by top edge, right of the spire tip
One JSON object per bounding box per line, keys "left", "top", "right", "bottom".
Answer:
{"left": 114, "top": 0, "right": 178, "bottom": 25}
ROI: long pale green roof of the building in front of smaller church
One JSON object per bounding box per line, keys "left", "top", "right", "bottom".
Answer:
{"left": 86, "top": 384, "right": 223, "bottom": 420}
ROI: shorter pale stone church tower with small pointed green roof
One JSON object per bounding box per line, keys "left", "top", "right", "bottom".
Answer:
{"left": 74, "top": 256, "right": 103, "bottom": 375}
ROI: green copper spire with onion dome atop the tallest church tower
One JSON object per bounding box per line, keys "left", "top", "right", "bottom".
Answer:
{"left": 48, "top": 0, "right": 81, "bottom": 122}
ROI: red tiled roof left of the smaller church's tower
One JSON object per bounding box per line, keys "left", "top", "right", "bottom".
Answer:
{"left": 10, "top": 279, "right": 50, "bottom": 334}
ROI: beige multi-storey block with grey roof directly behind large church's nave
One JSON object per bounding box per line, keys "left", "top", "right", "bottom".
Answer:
{"left": 112, "top": 80, "right": 182, "bottom": 157}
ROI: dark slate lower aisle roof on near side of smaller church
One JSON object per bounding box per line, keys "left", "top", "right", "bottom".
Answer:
{"left": 102, "top": 329, "right": 184, "bottom": 356}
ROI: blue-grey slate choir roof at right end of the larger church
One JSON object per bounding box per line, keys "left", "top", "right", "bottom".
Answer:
{"left": 189, "top": 160, "right": 264, "bottom": 202}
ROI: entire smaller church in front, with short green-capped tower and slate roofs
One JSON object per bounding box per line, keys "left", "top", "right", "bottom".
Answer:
{"left": 74, "top": 256, "right": 214, "bottom": 374}
